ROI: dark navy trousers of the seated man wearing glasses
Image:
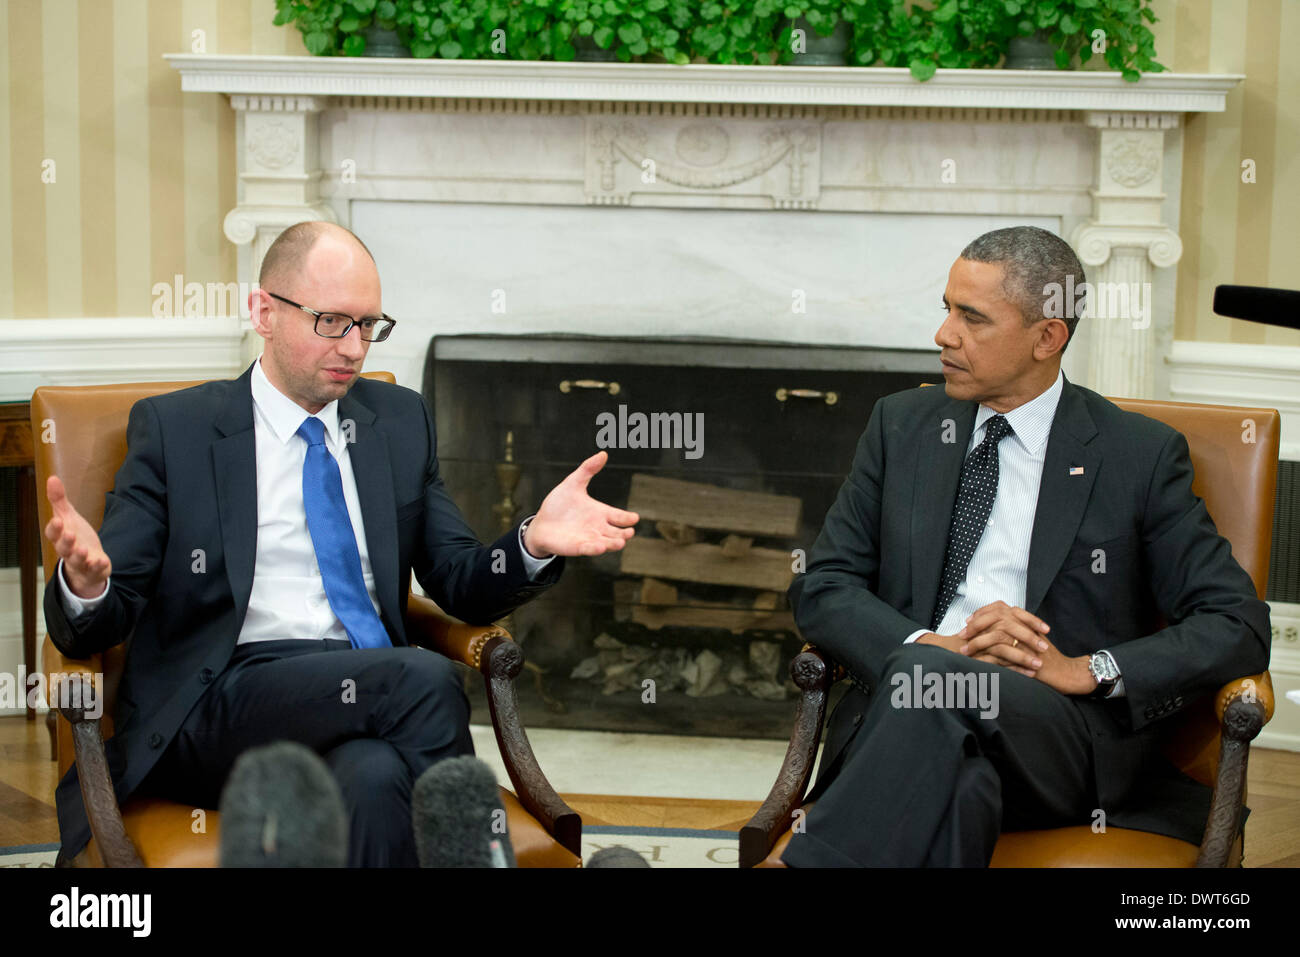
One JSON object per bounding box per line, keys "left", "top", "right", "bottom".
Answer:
{"left": 147, "top": 640, "right": 475, "bottom": 866}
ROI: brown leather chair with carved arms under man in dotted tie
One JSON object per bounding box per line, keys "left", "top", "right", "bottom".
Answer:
{"left": 740, "top": 399, "right": 1282, "bottom": 867}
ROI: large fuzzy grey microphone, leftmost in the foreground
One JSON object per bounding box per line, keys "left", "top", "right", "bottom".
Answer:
{"left": 221, "top": 741, "right": 347, "bottom": 867}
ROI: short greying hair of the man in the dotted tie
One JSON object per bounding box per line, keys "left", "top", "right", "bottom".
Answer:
{"left": 962, "top": 226, "right": 1087, "bottom": 352}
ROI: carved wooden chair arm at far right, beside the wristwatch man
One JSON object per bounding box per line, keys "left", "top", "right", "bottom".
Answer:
{"left": 1196, "top": 671, "right": 1273, "bottom": 867}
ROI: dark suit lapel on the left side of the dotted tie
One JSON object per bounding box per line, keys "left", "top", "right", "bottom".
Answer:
{"left": 911, "top": 399, "right": 979, "bottom": 628}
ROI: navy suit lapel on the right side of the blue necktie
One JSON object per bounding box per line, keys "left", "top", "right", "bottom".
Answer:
{"left": 338, "top": 385, "right": 404, "bottom": 640}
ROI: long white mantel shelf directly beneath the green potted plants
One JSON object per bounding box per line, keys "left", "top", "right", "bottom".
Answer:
{"left": 165, "top": 53, "right": 1244, "bottom": 113}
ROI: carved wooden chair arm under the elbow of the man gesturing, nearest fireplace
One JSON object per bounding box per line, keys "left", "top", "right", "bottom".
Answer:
{"left": 407, "top": 594, "right": 582, "bottom": 857}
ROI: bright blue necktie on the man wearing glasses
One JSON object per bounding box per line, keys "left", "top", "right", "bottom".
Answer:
{"left": 298, "top": 416, "right": 393, "bottom": 648}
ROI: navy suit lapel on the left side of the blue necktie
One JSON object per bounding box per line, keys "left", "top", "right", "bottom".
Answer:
{"left": 212, "top": 365, "right": 257, "bottom": 624}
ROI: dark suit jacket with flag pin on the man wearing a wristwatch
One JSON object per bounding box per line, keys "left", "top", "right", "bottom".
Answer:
{"left": 790, "top": 381, "right": 1270, "bottom": 844}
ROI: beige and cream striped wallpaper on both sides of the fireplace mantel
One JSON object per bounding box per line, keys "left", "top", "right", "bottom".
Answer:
{"left": 0, "top": 0, "right": 1300, "bottom": 346}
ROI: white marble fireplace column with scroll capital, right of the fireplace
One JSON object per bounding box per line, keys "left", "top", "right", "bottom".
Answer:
{"left": 1071, "top": 112, "right": 1183, "bottom": 398}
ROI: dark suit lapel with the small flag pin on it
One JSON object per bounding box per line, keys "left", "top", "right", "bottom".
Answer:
{"left": 1024, "top": 380, "right": 1101, "bottom": 614}
